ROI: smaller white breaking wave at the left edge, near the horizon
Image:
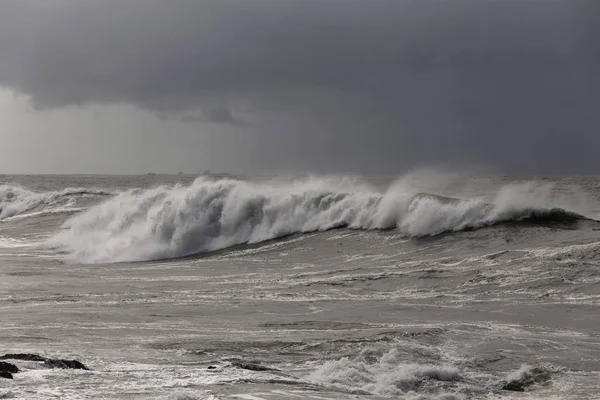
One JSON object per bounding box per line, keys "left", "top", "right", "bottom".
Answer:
{"left": 0, "top": 185, "right": 110, "bottom": 220}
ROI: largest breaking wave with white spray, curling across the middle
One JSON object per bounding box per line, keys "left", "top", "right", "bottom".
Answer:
{"left": 49, "top": 178, "right": 592, "bottom": 263}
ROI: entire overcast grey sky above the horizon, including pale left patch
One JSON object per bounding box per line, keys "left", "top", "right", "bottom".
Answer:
{"left": 0, "top": 0, "right": 600, "bottom": 174}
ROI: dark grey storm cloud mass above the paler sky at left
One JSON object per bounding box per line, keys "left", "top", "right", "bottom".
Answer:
{"left": 0, "top": 0, "right": 600, "bottom": 170}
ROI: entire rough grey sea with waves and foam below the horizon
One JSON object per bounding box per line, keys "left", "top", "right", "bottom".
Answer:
{"left": 0, "top": 171, "right": 600, "bottom": 400}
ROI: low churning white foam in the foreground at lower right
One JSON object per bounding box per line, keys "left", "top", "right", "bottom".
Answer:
{"left": 307, "top": 348, "right": 562, "bottom": 400}
